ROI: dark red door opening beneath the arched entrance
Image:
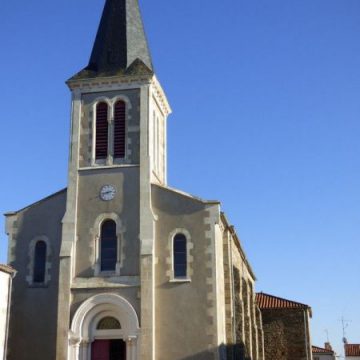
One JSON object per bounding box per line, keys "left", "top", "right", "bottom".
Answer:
{"left": 91, "top": 340, "right": 126, "bottom": 360}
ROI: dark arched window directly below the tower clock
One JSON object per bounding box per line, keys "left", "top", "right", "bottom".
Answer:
{"left": 100, "top": 220, "right": 117, "bottom": 271}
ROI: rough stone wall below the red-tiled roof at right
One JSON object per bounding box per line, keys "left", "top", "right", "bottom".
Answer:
{"left": 261, "top": 309, "right": 310, "bottom": 360}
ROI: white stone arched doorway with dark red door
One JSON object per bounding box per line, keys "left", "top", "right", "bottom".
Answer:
{"left": 69, "top": 294, "right": 140, "bottom": 360}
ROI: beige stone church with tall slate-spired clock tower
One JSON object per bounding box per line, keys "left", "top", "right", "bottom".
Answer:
{"left": 6, "top": 0, "right": 274, "bottom": 360}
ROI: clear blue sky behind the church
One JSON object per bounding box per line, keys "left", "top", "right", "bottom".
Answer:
{"left": 0, "top": 0, "right": 360, "bottom": 352}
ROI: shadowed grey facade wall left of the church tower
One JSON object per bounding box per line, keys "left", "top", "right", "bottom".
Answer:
{"left": 6, "top": 190, "right": 66, "bottom": 360}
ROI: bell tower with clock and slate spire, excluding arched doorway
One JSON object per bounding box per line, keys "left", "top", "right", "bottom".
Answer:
{"left": 56, "top": 0, "right": 171, "bottom": 360}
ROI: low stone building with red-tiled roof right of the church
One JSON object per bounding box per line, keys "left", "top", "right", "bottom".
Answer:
{"left": 256, "top": 293, "right": 312, "bottom": 360}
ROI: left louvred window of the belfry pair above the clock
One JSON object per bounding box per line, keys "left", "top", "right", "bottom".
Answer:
{"left": 95, "top": 102, "right": 109, "bottom": 160}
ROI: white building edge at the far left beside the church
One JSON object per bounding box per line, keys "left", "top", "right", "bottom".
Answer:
{"left": 0, "top": 264, "right": 15, "bottom": 360}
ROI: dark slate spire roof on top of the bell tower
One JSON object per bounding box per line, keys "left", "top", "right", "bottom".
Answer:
{"left": 70, "top": 0, "right": 153, "bottom": 80}
